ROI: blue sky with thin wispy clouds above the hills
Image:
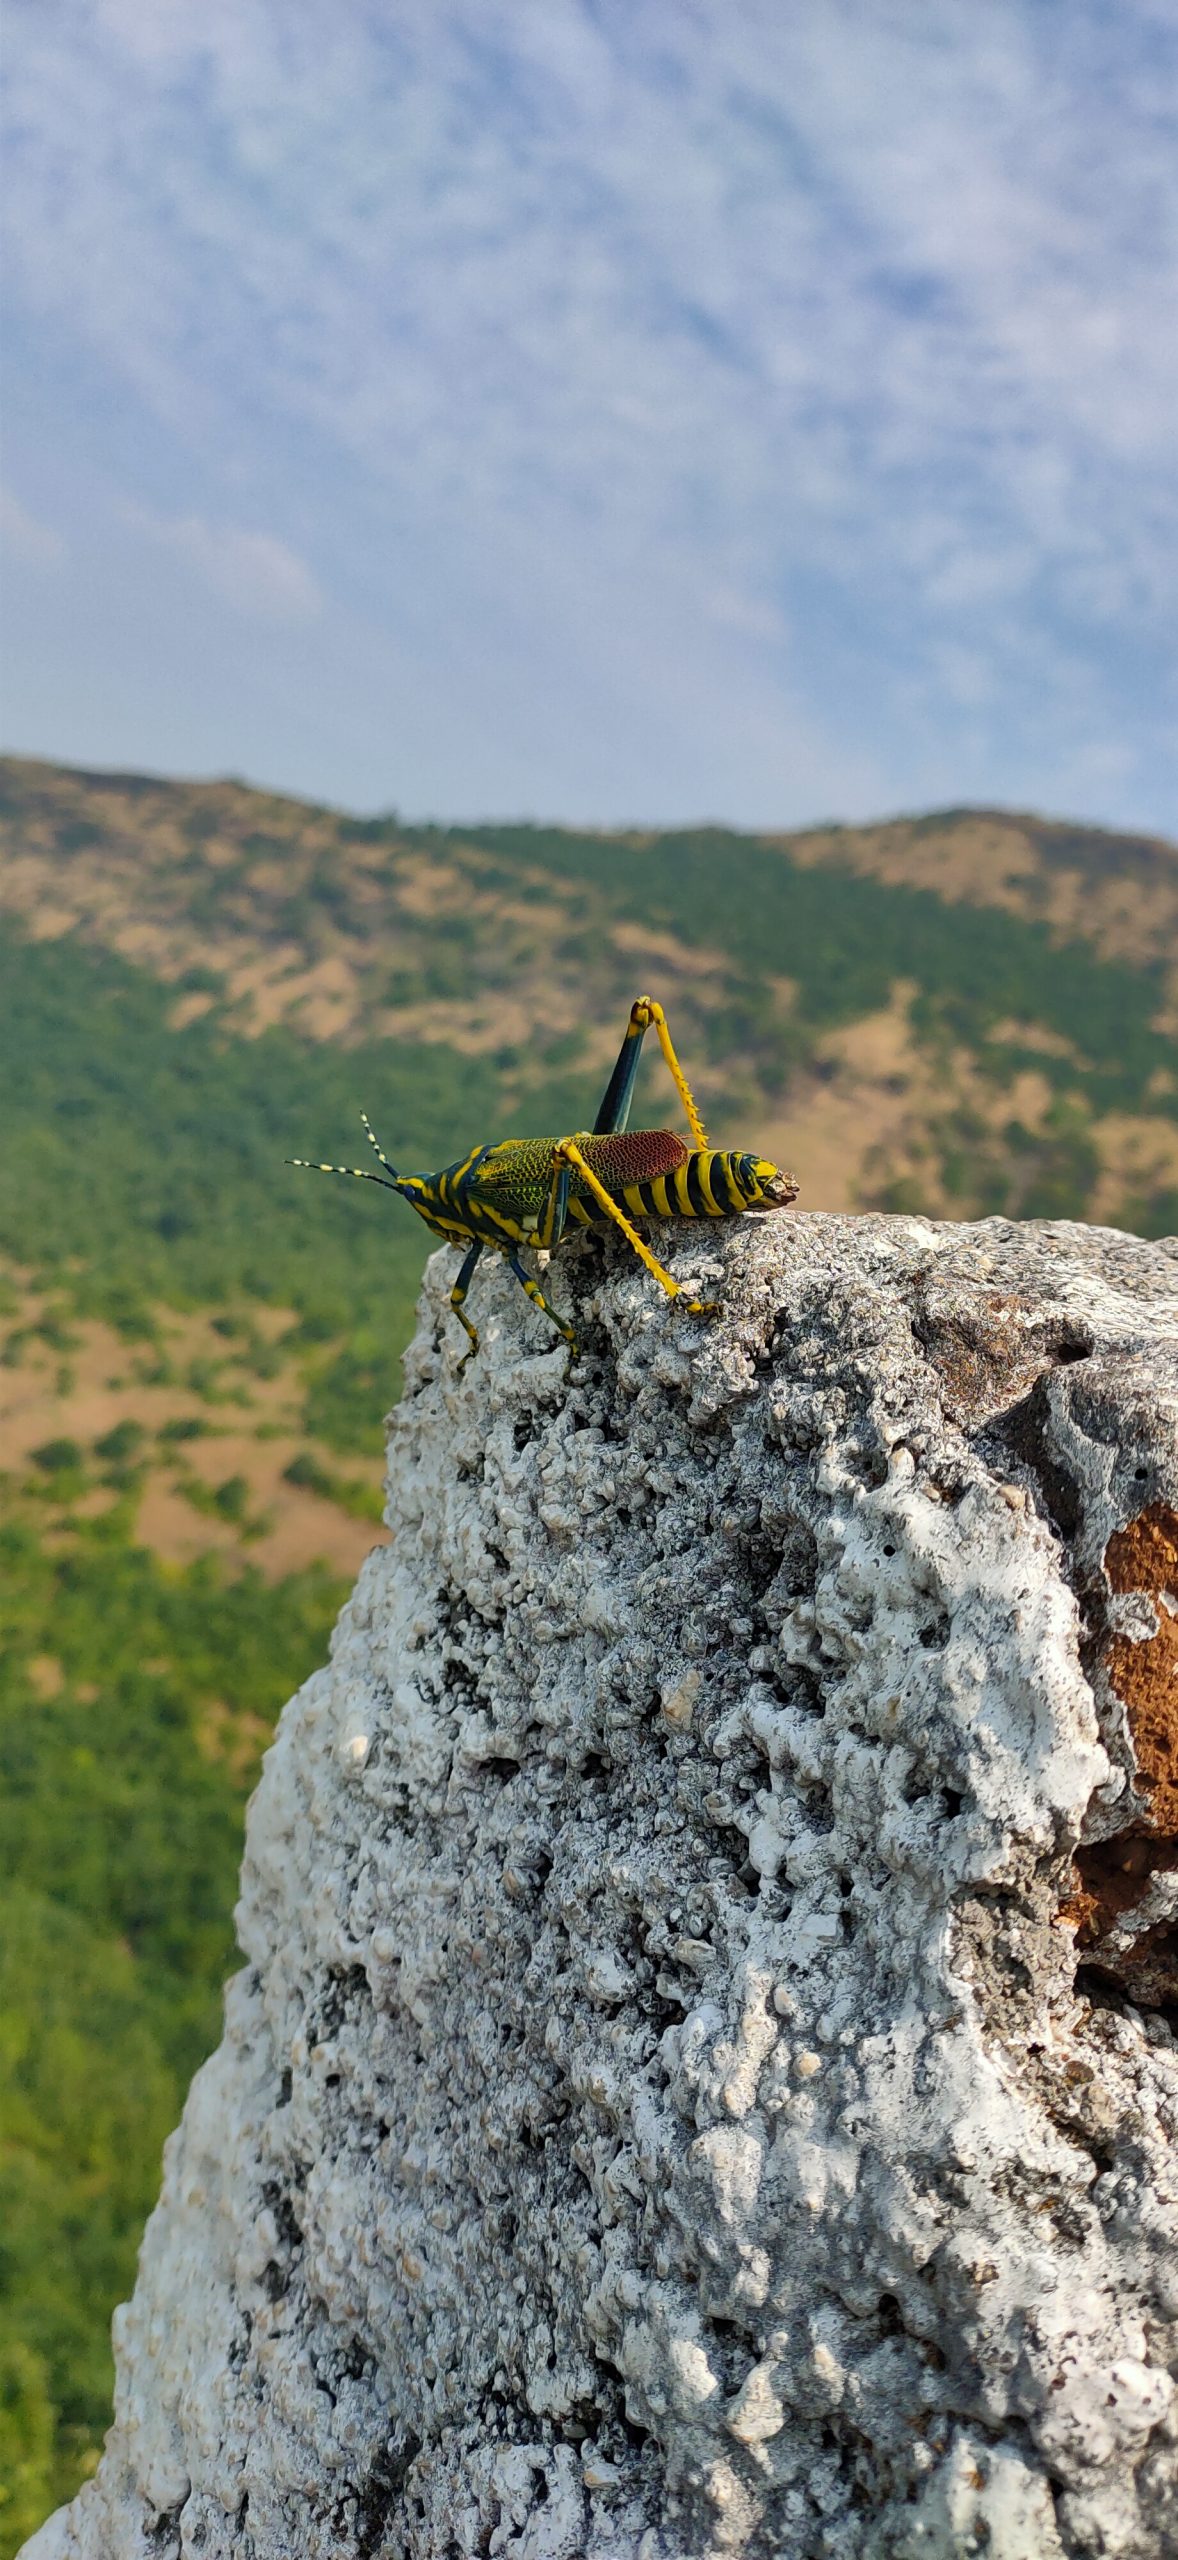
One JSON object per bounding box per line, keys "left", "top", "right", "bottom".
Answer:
{"left": 0, "top": 0, "right": 1178, "bottom": 832}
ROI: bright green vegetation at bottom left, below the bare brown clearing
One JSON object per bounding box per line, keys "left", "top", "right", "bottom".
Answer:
{"left": 0, "top": 1498, "right": 343, "bottom": 2560}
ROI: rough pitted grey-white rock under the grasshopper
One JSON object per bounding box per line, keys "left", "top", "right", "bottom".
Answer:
{"left": 31, "top": 1216, "right": 1178, "bottom": 2560}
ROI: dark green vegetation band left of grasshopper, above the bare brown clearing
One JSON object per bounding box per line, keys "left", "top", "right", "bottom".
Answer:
{"left": 0, "top": 929, "right": 468, "bottom": 1403}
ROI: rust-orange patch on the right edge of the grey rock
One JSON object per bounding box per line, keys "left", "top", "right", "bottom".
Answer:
{"left": 1104, "top": 1503, "right": 1178, "bottom": 1836}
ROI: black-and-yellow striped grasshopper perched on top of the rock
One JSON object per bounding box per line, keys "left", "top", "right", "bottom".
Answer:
{"left": 287, "top": 996, "right": 796, "bottom": 1370}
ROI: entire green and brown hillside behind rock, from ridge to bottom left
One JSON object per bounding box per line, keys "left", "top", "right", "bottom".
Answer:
{"left": 0, "top": 758, "right": 1178, "bottom": 2560}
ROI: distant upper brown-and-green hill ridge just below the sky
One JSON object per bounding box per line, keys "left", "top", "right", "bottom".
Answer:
{"left": 0, "top": 760, "right": 1178, "bottom": 1231}
